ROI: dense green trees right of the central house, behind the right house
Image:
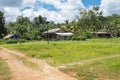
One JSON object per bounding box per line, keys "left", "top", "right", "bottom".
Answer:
{"left": 64, "top": 7, "right": 120, "bottom": 38}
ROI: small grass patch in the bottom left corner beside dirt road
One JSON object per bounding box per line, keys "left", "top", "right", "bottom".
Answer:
{"left": 0, "top": 58, "right": 11, "bottom": 80}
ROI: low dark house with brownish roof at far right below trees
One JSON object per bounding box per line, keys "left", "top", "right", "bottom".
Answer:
{"left": 91, "top": 32, "right": 112, "bottom": 38}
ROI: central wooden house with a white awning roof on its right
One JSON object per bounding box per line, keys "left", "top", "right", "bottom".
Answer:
{"left": 43, "top": 28, "right": 73, "bottom": 40}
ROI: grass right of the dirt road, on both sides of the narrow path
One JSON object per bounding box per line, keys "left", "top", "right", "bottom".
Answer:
{"left": 2, "top": 38, "right": 120, "bottom": 80}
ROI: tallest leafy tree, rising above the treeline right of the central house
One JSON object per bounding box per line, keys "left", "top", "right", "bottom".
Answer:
{"left": 78, "top": 7, "right": 104, "bottom": 32}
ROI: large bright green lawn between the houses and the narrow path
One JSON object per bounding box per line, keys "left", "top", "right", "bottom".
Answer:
{"left": 2, "top": 38, "right": 120, "bottom": 66}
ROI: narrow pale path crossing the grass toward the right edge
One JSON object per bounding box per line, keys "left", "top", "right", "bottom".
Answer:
{"left": 56, "top": 54, "right": 120, "bottom": 69}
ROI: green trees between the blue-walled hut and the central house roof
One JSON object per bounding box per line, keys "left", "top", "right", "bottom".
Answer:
{"left": 6, "top": 16, "right": 57, "bottom": 40}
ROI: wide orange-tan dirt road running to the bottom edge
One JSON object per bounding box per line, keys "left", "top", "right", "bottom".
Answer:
{"left": 0, "top": 48, "right": 75, "bottom": 80}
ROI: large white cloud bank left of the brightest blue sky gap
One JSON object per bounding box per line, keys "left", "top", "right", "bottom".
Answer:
{"left": 0, "top": 0, "right": 84, "bottom": 23}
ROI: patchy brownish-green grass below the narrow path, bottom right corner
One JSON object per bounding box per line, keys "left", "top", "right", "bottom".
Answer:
{"left": 62, "top": 57, "right": 120, "bottom": 80}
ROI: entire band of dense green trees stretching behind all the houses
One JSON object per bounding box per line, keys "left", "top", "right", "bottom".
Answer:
{"left": 0, "top": 7, "right": 120, "bottom": 40}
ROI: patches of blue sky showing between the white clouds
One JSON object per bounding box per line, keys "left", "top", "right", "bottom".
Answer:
{"left": 21, "top": 0, "right": 101, "bottom": 12}
